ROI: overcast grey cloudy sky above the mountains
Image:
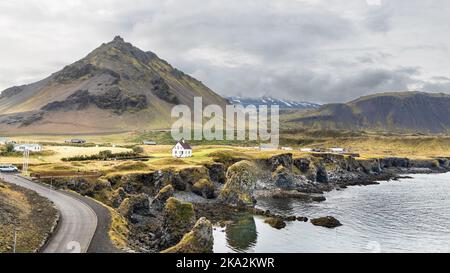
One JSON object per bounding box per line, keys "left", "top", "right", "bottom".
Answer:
{"left": 0, "top": 0, "right": 450, "bottom": 103}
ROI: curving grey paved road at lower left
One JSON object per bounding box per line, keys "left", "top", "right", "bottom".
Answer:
{"left": 0, "top": 173, "right": 98, "bottom": 253}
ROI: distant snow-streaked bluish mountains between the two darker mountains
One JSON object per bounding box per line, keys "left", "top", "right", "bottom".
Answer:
{"left": 227, "top": 96, "right": 320, "bottom": 110}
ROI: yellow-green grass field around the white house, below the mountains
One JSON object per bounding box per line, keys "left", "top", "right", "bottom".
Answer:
{"left": 0, "top": 130, "right": 450, "bottom": 176}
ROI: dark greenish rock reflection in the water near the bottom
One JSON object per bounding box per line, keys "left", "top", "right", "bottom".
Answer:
{"left": 225, "top": 214, "right": 258, "bottom": 252}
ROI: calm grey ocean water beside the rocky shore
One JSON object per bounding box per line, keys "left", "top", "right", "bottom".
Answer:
{"left": 214, "top": 173, "right": 450, "bottom": 253}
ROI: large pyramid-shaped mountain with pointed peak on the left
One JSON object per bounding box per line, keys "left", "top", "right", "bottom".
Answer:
{"left": 0, "top": 36, "right": 227, "bottom": 133}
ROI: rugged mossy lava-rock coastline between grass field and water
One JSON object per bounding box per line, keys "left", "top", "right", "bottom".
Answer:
{"left": 34, "top": 153, "right": 450, "bottom": 252}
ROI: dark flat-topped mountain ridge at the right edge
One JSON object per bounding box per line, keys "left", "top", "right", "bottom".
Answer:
{"left": 289, "top": 91, "right": 450, "bottom": 133}
